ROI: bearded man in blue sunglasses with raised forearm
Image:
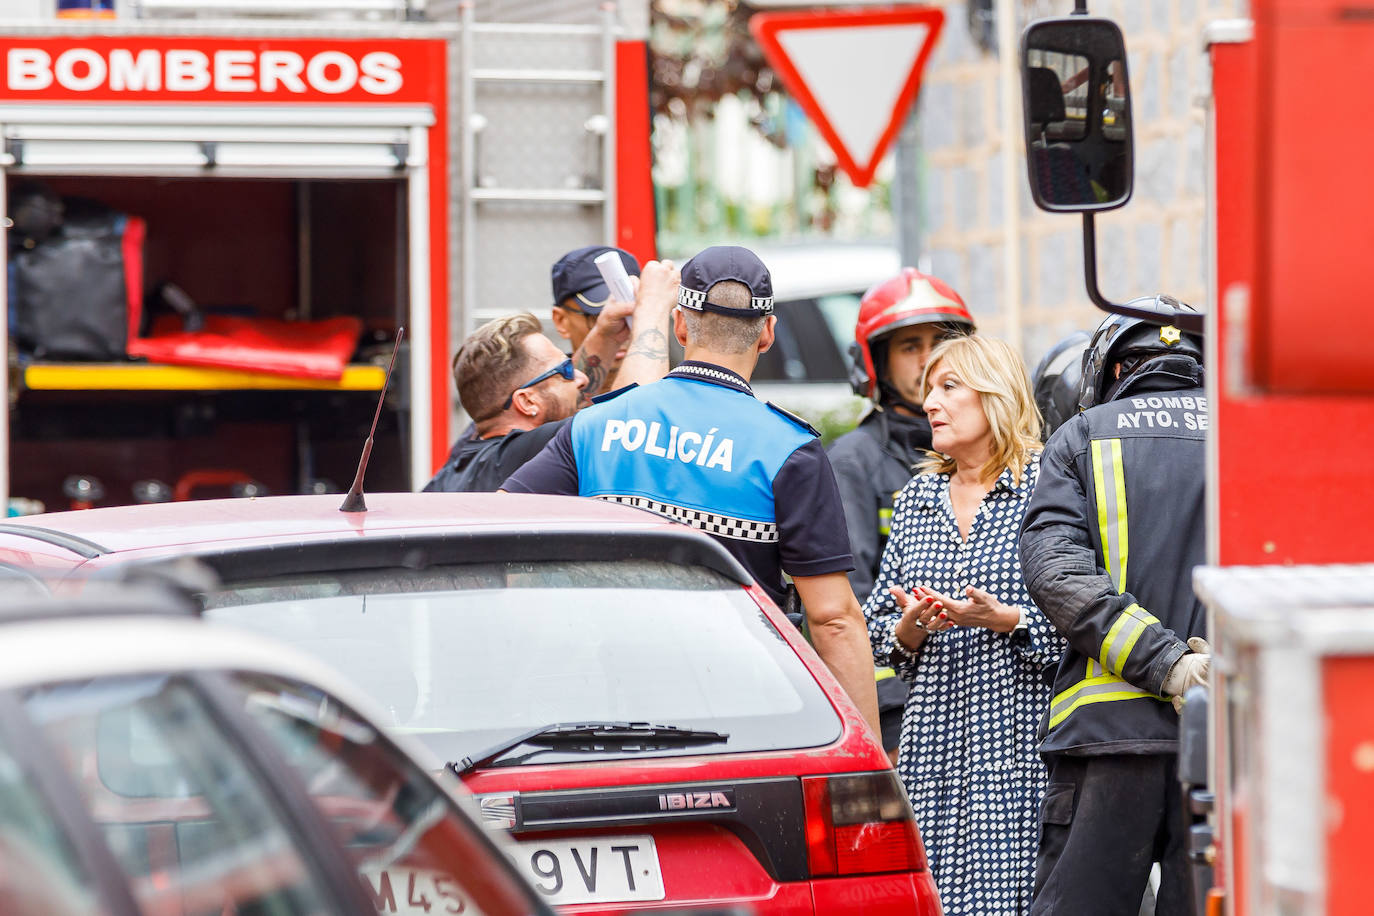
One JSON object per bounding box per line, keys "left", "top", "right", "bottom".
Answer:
{"left": 425, "top": 261, "right": 677, "bottom": 493}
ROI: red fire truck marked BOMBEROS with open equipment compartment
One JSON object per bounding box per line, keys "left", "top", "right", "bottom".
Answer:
{"left": 0, "top": 0, "right": 654, "bottom": 508}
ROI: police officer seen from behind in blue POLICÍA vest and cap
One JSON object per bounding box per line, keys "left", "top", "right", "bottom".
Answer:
{"left": 502, "top": 246, "right": 878, "bottom": 729}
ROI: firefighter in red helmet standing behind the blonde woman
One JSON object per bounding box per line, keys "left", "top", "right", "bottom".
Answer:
{"left": 830, "top": 268, "right": 974, "bottom": 769}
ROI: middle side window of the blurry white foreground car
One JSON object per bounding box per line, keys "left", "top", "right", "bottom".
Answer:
{"left": 25, "top": 677, "right": 331, "bottom": 916}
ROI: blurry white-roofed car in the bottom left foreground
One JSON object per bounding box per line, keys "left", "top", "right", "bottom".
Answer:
{"left": 0, "top": 585, "right": 548, "bottom": 916}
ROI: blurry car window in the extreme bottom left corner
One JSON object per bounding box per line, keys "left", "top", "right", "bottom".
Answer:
{"left": 0, "top": 742, "right": 109, "bottom": 916}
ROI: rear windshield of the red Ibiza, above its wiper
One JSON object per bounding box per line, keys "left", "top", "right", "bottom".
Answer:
{"left": 206, "top": 560, "right": 840, "bottom": 764}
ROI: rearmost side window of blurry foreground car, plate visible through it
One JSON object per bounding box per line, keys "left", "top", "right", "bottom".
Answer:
{"left": 234, "top": 674, "right": 538, "bottom": 916}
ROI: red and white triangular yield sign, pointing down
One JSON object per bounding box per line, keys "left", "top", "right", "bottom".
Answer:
{"left": 749, "top": 7, "right": 944, "bottom": 187}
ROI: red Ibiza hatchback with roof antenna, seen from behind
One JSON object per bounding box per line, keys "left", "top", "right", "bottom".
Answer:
{"left": 0, "top": 493, "right": 940, "bottom": 916}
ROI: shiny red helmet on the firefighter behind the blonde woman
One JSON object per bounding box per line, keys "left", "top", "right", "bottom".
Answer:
{"left": 849, "top": 268, "right": 977, "bottom": 398}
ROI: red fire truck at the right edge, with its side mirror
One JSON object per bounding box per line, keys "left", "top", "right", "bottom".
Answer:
{"left": 1022, "top": 0, "right": 1374, "bottom": 916}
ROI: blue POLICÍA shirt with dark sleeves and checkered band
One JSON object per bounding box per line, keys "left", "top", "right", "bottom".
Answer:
{"left": 502, "top": 361, "right": 853, "bottom": 603}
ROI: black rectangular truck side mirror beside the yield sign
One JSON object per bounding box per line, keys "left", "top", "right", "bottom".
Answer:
{"left": 1021, "top": 15, "right": 1135, "bottom": 213}
